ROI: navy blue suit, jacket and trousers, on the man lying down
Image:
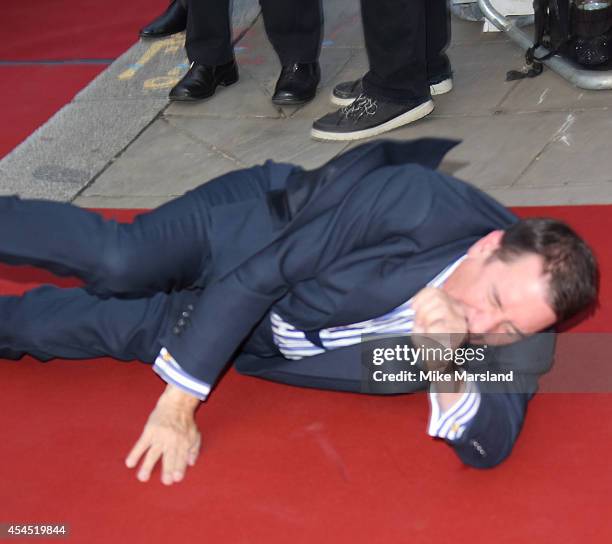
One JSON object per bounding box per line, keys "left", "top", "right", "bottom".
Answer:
{"left": 0, "top": 139, "right": 553, "bottom": 467}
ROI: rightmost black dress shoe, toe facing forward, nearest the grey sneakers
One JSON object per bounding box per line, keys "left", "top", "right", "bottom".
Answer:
{"left": 272, "top": 62, "right": 321, "bottom": 106}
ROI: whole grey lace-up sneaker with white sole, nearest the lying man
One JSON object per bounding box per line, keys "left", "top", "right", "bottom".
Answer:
{"left": 310, "top": 93, "right": 434, "bottom": 141}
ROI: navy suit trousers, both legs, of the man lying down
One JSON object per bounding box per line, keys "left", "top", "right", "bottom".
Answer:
{"left": 0, "top": 166, "right": 278, "bottom": 362}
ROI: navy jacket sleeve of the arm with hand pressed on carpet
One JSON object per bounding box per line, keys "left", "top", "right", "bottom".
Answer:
{"left": 160, "top": 165, "right": 435, "bottom": 385}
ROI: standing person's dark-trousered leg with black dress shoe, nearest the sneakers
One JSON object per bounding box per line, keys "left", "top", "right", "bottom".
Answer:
{"left": 260, "top": 0, "right": 323, "bottom": 105}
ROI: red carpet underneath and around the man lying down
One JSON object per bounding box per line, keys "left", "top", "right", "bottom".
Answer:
{"left": 0, "top": 206, "right": 612, "bottom": 544}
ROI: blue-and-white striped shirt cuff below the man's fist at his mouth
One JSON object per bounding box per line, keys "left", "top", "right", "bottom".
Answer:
{"left": 427, "top": 382, "right": 480, "bottom": 440}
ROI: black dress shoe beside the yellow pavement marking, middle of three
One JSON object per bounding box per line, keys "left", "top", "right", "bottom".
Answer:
{"left": 169, "top": 60, "right": 238, "bottom": 102}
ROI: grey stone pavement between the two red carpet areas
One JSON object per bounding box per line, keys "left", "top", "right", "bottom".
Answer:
{"left": 0, "top": 0, "right": 612, "bottom": 208}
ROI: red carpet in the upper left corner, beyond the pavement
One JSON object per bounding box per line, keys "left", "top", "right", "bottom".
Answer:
{"left": 0, "top": 0, "right": 167, "bottom": 159}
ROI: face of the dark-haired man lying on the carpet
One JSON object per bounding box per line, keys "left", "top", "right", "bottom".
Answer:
{"left": 443, "top": 231, "right": 556, "bottom": 344}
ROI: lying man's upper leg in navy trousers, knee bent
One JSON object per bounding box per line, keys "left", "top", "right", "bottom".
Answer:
{"left": 0, "top": 166, "right": 270, "bottom": 296}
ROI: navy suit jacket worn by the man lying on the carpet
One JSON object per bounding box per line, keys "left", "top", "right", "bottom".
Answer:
{"left": 162, "top": 139, "right": 553, "bottom": 467}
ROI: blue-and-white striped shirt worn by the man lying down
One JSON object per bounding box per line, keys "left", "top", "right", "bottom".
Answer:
{"left": 153, "top": 256, "right": 480, "bottom": 441}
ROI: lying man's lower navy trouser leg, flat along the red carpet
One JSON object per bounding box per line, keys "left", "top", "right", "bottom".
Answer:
{"left": 0, "top": 286, "right": 172, "bottom": 362}
